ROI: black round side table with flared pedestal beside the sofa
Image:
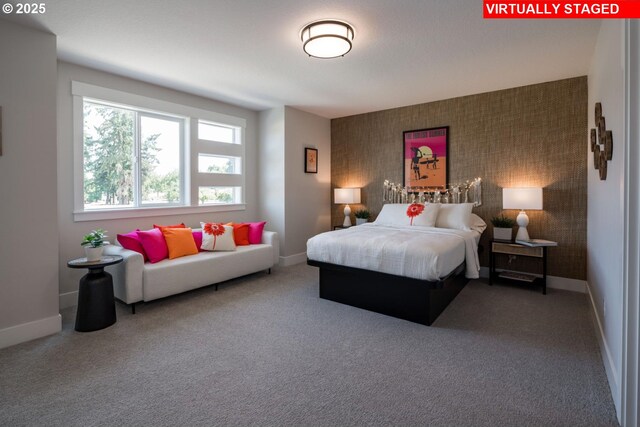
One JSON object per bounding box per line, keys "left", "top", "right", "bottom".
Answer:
{"left": 67, "top": 255, "right": 122, "bottom": 332}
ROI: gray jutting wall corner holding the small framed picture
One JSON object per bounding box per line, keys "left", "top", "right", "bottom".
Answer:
{"left": 259, "top": 107, "right": 331, "bottom": 265}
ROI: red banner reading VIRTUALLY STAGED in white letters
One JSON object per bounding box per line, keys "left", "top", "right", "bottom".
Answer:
{"left": 482, "top": 0, "right": 640, "bottom": 19}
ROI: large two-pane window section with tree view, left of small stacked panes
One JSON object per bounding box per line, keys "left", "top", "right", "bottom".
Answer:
{"left": 83, "top": 99, "right": 185, "bottom": 210}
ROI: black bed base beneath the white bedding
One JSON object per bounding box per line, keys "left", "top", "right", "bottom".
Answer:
{"left": 307, "top": 260, "right": 468, "bottom": 326}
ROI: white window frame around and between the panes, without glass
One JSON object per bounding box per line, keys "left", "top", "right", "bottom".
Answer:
{"left": 71, "top": 81, "right": 246, "bottom": 221}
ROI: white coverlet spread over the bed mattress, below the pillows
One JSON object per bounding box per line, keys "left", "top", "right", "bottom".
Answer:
{"left": 307, "top": 224, "right": 480, "bottom": 281}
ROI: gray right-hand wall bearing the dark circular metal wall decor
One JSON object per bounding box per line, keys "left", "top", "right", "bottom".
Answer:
{"left": 584, "top": 20, "right": 625, "bottom": 422}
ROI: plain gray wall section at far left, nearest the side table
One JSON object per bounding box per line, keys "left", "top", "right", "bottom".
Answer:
{"left": 0, "top": 20, "right": 60, "bottom": 347}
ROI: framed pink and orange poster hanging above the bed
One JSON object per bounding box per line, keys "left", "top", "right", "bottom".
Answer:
{"left": 402, "top": 126, "right": 449, "bottom": 190}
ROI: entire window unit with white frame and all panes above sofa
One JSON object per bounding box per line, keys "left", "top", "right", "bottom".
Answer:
{"left": 72, "top": 82, "right": 246, "bottom": 221}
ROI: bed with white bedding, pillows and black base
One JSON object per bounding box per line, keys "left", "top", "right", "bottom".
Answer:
{"left": 307, "top": 179, "right": 486, "bottom": 325}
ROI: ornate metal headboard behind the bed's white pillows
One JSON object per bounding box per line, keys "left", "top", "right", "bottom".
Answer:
{"left": 382, "top": 178, "right": 482, "bottom": 206}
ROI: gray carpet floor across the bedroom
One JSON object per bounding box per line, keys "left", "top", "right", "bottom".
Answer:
{"left": 0, "top": 265, "right": 617, "bottom": 426}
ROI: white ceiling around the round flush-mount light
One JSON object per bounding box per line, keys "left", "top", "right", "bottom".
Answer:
{"left": 9, "top": 0, "right": 600, "bottom": 118}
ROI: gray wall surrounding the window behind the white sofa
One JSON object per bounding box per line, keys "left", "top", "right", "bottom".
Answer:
{"left": 58, "top": 62, "right": 268, "bottom": 305}
